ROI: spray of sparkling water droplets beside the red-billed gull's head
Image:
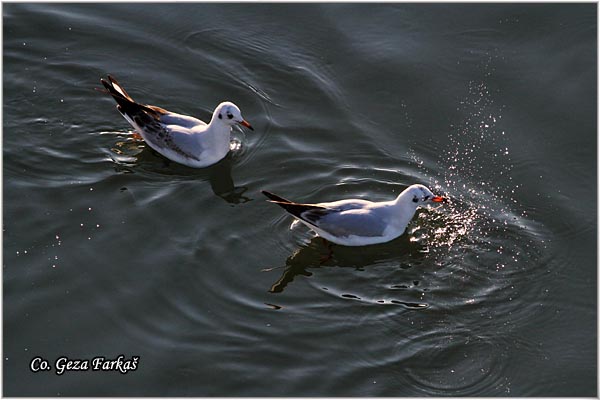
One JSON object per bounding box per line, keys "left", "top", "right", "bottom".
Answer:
{"left": 411, "top": 72, "right": 518, "bottom": 253}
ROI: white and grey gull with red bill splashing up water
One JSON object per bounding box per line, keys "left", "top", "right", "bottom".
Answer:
{"left": 262, "top": 184, "right": 446, "bottom": 246}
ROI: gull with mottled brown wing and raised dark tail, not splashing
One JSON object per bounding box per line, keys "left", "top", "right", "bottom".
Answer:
{"left": 100, "top": 75, "right": 254, "bottom": 168}
